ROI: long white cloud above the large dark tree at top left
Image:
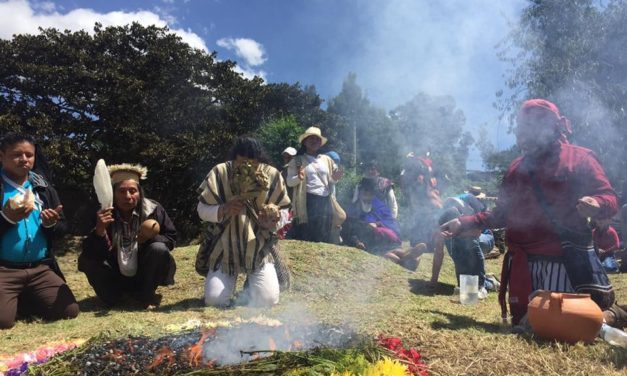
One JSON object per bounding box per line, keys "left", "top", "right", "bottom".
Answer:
{"left": 0, "top": 0, "right": 208, "bottom": 51}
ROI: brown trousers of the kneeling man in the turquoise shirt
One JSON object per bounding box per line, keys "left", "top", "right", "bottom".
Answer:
{"left": 0, "top": 264, "right": 79, "bottom": 329}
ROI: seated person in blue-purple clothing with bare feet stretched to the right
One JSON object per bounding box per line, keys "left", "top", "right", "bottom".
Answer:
{"left": 342, "top": 178, "right": 418, "bottom": 270}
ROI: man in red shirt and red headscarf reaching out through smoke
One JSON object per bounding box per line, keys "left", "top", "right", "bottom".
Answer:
{"left": 441, "top": 99, "right": 618, "bottom": 324}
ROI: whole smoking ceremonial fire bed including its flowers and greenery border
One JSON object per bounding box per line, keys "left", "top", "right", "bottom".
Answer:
{"left": 15, "top": 316, "right": 427, "bottom": 376}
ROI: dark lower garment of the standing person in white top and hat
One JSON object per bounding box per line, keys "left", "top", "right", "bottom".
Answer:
{"left": 296, "top": 193, "right": 332, "bottom": 243}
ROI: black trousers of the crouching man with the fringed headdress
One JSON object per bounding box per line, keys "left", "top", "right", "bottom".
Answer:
{"left": 79, "top": 242, "right": 176, "bottom": 306}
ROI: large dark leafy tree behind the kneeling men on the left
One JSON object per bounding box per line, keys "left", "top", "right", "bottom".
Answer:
{"left": 0, "top": 24, "right": 320, "bottom": 236}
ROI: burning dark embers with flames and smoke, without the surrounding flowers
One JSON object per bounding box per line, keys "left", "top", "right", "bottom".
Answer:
{"left": 59, "top": 322, "right": 355, "bottom": 375}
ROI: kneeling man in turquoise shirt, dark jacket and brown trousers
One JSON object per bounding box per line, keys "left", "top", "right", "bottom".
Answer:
{"left": 0, "top": 134, "right": 79, "bottom": 329}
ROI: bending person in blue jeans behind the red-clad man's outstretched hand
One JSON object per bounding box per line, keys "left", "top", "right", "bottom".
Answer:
{"left": 431, "top": 194, "right": 496, "bottom": 299}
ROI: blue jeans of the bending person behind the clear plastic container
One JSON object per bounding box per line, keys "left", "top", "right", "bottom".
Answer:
{"left": 445, "top": 237, "right": 485, "bottom": 288}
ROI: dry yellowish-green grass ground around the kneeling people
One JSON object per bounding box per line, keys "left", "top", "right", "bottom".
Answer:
{"left": 0, "top": 241, "right": 627, "bottom": 375}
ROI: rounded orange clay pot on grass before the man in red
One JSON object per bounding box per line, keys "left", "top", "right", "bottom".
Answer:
{"left": 528, "top": 290, "right": 603, "bottom": 343}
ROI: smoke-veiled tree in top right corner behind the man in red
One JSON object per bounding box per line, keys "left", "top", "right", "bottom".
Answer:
{"left": 498, "top": 0, "right": 627, "bottom": 189}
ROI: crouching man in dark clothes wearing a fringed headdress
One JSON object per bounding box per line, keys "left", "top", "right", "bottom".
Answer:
{"left": 78, "top": 164, "right": 176, "bottom": 309}
